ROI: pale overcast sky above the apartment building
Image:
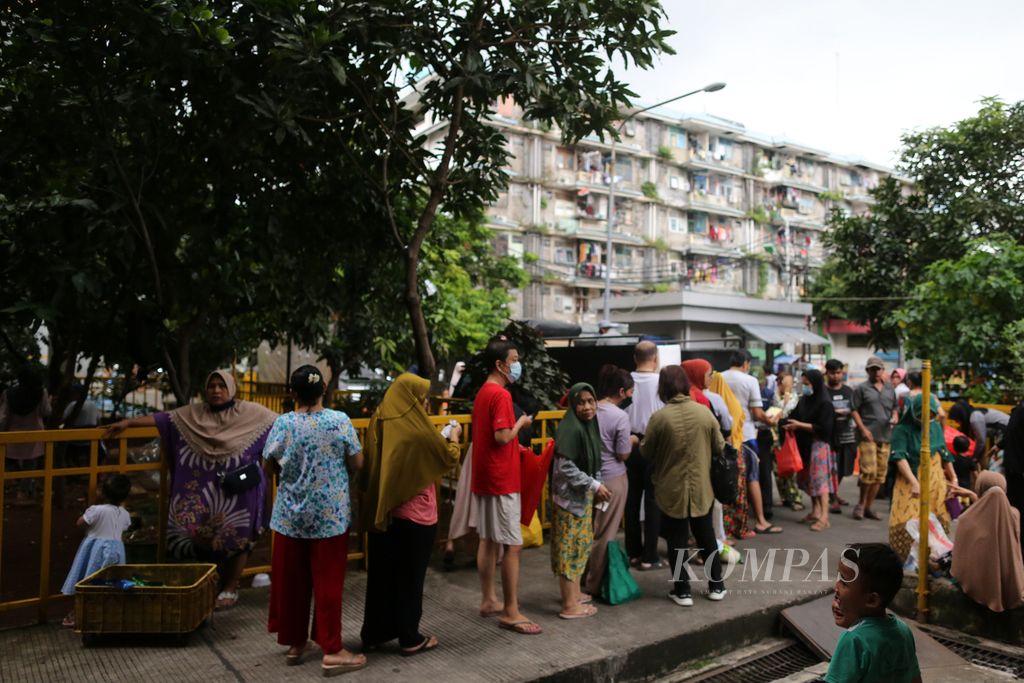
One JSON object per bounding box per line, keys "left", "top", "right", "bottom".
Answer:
{"left": 626, "top": 0, "right": 1024, "bottom": 165}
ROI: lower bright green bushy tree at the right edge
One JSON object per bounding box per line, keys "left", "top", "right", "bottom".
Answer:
{"left": 893, "top": 237, "right": 1024, "bottom": 377}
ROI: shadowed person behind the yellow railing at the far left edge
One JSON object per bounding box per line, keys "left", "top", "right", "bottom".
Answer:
{"left": 0, "top": 364, "right": 50, "bottom": 504}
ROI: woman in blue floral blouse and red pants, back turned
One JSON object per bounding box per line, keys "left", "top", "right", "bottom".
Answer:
{"left": 263, "top": 366, "right": 367, "bottom": 676}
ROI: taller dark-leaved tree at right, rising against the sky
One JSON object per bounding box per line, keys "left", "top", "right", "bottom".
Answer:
{"left": 810, "top": 98, "right": 1024, "bottom": 347}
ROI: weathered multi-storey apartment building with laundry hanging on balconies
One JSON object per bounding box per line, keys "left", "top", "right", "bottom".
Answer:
{"left": 419, "top": 95, "right": 889, "bottom": 345}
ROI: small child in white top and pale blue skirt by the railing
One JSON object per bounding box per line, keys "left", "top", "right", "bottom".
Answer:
{"left": 60, "top": 474, "right": 131, "bottom": 628}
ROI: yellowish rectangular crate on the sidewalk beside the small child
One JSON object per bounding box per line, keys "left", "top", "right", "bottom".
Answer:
{"left": 75, "top": 564, "right": 217, "bottom": 640}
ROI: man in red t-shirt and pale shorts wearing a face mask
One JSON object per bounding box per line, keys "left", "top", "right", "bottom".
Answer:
{"left": 471, "top": 337, "right": 542, "bottom": 635}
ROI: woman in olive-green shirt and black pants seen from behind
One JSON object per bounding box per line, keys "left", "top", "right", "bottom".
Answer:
{"left": 640, "top": 366, "right": 725, "bottom": 607}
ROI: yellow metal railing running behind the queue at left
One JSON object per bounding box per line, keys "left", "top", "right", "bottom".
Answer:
{"left": 0, "top": 411, "right": 564, "bottom": 622}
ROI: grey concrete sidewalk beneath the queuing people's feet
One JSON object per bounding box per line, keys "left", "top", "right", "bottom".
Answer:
{"left": 0, "top": 480, "right": 887, "bottom": 683}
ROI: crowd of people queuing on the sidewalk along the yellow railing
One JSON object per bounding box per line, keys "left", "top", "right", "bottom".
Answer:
{"left": 3, "top": 337, "right": 1024, "bottom": 675}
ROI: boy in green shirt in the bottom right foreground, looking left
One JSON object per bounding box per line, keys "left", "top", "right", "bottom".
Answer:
{"left": 824, "top": 543, "right": 921, "bottom": 683}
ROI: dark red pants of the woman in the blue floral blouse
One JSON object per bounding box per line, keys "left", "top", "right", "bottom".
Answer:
{"left": 267, "top": 531, "right": 348, "bottom": 654}
